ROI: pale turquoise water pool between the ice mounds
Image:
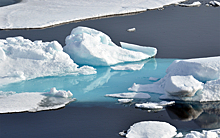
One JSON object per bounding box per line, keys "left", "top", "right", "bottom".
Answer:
{"left": 0, "top": 58, "right": 175, "bottom": 102}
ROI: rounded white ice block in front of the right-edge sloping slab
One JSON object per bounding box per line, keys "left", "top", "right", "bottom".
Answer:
{"left": 164, "top": 75, "right": 203, "bottom": 97}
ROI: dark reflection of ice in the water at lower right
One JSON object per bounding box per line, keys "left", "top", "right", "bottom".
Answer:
{"left": 166, "top": 102, "right": 220, "bottom": 129}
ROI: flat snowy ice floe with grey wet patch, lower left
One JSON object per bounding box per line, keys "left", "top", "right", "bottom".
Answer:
{"left": 0, "top": 88, "right": 75, "bottom": 113}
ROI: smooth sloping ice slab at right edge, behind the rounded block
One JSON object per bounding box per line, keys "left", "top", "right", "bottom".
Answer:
{"left": 166, "top": 56, "right": 220, "bottom": 82}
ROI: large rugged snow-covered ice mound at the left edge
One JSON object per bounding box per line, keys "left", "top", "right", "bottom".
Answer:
{"left": 0, "top": 36, "right": 96, "bottom": 85}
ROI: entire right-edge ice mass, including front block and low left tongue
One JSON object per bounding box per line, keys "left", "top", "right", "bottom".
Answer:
{"left": 128, "top": 56, "right": 220, "bottom": 102}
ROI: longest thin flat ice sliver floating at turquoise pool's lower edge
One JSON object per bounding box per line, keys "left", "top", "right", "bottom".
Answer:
{"left": 105, "top": 92, "right": 150, "bottom": 99}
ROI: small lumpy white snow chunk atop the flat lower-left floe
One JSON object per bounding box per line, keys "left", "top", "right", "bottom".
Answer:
{"left": 45, "top": 87, "right": 73, "bottom": 98}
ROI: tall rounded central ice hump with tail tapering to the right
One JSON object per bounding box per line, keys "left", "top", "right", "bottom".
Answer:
{"left": 64, "top": 27, "right": 156, "bottom": 66}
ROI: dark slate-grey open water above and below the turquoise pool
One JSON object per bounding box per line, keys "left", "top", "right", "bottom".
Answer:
{"left": 0, "top": 1, "right": 220, "bottom": 138}
